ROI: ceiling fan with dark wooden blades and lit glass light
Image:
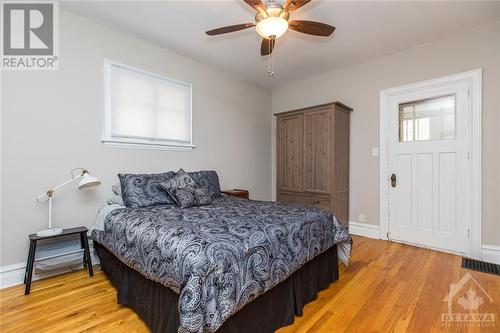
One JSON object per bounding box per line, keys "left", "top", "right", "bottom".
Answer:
{"left": 206, "top": 0, "right": 335, "bottom": 56}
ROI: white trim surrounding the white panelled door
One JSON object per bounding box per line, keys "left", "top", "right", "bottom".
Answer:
{"left": 379, "top": 68, "right": 483, "bottom": 260}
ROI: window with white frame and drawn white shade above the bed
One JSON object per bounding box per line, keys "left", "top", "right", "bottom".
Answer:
{"left": 103, "top": 61, "right": 194, "bottom": 150}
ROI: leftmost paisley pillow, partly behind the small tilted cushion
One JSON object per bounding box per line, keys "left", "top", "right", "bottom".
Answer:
{"left": 118, "top": 171, "right": 176, "bottom": 208}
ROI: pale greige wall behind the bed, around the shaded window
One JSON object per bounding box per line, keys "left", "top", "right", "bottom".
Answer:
{"left": 0, "top": 11, "right": 271, "bottom": 266}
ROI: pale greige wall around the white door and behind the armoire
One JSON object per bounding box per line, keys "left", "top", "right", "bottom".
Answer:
{"left": 272, "top": 22, "right": 500, "bottom": 245}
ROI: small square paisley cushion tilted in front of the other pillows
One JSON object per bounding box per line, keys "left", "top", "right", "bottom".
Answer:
{"left": 160, "top": 169, "right": 213, "bottom": 208}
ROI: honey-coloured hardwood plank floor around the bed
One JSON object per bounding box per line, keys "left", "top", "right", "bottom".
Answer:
{"left": 0, "top": 237, "right": 500, "bottom": 333}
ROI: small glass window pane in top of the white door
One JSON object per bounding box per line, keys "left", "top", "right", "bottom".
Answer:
{"left": 399, "top": 95, "right": 455, "bottom": 141}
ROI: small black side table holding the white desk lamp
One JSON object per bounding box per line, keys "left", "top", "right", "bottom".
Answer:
{"left": 24, "top": 227, "right": 94, "bottom": 295}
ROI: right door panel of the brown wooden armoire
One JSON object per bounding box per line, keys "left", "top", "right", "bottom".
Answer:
{"left": 303, "top": 108, "right": 332, "bottom": 194}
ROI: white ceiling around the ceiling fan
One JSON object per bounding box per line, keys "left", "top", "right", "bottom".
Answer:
{"left": 61, "top": 0, "right": 500, "bottom": 87}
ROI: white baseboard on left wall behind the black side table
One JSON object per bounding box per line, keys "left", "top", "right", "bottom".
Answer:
{"left": 0, "top": 249, "right": 99, "bottom": 289}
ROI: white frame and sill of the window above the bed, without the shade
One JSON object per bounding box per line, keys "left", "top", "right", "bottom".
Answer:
{"left": 101, "top": 59, "right": 196, "bottom": 151}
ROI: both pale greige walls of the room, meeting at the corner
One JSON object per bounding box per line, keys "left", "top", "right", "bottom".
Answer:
{"left": 0, "top": 11, "right": 500, "bottom": 266}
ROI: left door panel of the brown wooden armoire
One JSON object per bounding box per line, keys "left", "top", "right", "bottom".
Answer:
{"left": 277, "top": 114, "right": 303, "bottom": 192}
